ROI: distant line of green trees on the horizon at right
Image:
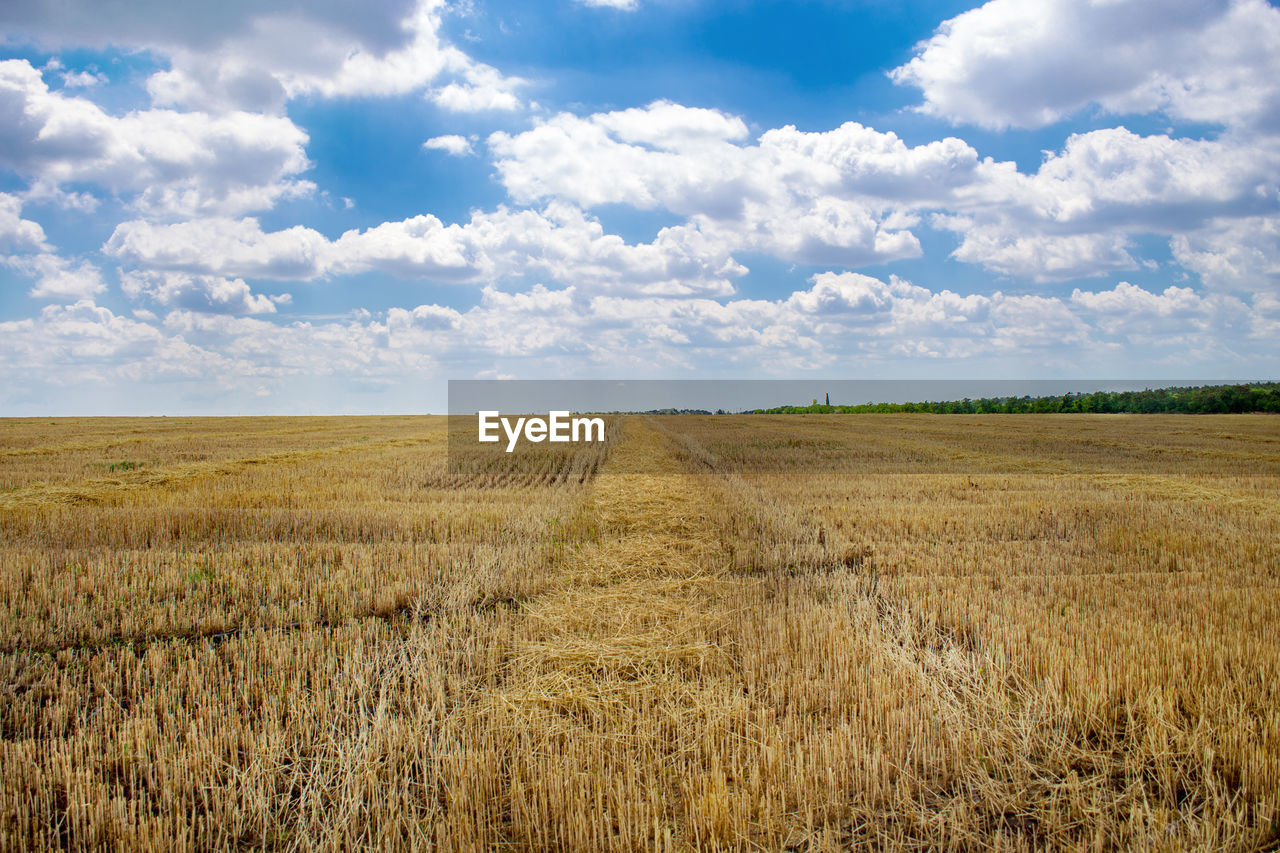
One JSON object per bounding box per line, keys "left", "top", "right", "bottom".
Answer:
{"left": 748, "top": 382, "right": 1280, "bottom": 415}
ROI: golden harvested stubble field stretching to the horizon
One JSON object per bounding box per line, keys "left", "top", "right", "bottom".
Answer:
{"left": 0, "top": 415, "right": 1280, "bottom": 850}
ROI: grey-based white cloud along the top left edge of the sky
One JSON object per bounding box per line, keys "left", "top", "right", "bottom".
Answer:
{"left": 5, "top": 0, "right": 524, "bottom": 113}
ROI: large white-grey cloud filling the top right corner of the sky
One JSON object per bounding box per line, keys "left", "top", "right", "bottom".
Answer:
{"left": 891, "top": 0, "right": 1280, "bottom": 128}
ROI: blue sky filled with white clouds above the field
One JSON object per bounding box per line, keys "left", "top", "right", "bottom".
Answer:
{"left": 0, "top": 0, "right": 1280, "bottom": 415}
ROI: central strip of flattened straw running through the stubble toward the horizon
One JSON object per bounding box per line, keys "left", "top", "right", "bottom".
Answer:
{"left": 445, "top": 420, "right": 750, "bottom": 849}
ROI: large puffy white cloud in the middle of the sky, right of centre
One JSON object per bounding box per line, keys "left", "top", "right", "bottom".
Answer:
{"left": 489, "top": 101, "right": 997, "bottom": 265}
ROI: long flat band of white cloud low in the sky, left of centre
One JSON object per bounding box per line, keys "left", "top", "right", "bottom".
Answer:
{"left": 104, "top": 202, "right": 746, "bottom": 296}
